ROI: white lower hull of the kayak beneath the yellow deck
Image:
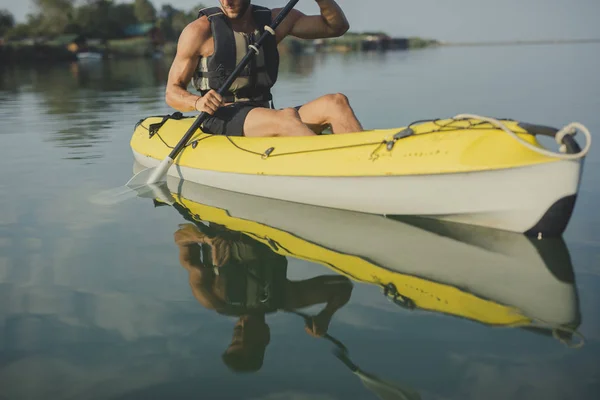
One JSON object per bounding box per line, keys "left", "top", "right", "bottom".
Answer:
{"left": 134, "top": 152, "right": 582, "bottom": 236}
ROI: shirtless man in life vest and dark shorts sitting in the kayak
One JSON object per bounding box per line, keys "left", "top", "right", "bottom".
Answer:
{"left": 165, "top": 0, "right": 363, "bottom": 137}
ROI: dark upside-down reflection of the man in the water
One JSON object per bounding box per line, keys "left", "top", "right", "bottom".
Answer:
{"left": 175, "top": 224, "right": 352, "bottom": 372}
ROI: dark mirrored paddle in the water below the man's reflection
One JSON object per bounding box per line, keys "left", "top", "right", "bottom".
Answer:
{"left": 285, "top": 309, "right": 421, "bottom": 400}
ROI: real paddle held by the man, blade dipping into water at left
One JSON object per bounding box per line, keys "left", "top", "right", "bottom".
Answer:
{"left": 92, "top": 0, "right": 299, "bottom": 204}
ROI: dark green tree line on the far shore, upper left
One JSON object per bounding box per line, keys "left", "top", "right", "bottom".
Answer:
{"left": 0, "top": 0, "right": 204, "bottom": 40}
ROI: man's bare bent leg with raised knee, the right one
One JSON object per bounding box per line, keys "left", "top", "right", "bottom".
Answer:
{"left": 298, "top": 93, "right": 363, "bottom": 133}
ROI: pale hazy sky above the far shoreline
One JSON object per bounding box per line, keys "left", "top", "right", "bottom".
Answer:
{"left": 0, "top": 0, "right": 600, "bottom": 42}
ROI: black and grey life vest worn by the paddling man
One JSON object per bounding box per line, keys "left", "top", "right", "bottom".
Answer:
{"left": 192, "top": 5, "right": 279, "bottom": 103}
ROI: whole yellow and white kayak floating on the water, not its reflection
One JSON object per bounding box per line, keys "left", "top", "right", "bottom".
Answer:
{"left": 130, "top": 113, "right": 591, "bottom": 237}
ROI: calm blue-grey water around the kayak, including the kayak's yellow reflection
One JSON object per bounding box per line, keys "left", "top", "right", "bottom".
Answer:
{"left": 0, "top": 45, "right": 600, "bottom": 400}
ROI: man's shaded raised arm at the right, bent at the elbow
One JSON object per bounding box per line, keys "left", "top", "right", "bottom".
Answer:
{"left": 273, "top": 0, "right": 350, "bottom": 42}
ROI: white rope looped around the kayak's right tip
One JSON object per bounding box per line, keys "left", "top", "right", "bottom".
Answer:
{"left": 454, "top": 114, "right": 592, "bottom": 160}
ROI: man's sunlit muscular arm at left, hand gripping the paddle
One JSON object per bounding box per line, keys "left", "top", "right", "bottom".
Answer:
{"left": 165, "top": 17, "right": 222, "bottom": 114}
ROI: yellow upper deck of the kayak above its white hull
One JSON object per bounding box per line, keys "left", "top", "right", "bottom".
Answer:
{"left": 131, "top": 117, "right": 557, "bottom": 176}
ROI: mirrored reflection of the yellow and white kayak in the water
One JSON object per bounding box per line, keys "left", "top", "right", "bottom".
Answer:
{"left": 143, "top": 170, "right": 581, "bottom": 341}
